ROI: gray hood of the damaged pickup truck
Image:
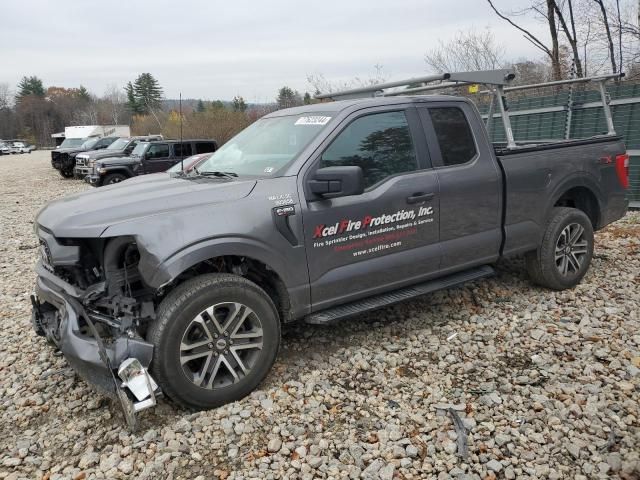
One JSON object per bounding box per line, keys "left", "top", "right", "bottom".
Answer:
{"left": 36, "top": 173, "right": 256, "bottom": 238}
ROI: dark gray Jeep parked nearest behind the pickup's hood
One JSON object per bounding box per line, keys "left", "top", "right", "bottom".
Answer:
{"left": 84, "top": 140, "right": 217, "bottom": 187}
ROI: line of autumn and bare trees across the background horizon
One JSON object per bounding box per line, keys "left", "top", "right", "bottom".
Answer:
{"left": 0, "top": 0, "right": 640, "bottom": 146}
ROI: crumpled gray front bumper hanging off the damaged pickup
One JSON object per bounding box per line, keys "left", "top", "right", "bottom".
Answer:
{"left": 32, "top": 262, "right": 153, "bottom": 396}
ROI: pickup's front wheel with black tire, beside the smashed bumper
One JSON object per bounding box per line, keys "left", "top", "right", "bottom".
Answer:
{"left": 147, "top": 273, "right": 280, "bottom": 409}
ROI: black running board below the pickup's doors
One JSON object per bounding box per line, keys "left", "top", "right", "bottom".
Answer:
{"left": 304, "top": 265, "right": 495, "bottom": 325}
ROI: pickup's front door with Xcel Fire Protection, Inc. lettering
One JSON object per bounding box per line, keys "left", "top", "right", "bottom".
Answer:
{"left": 301, "top": 106, "right": 440, "bottom": 311}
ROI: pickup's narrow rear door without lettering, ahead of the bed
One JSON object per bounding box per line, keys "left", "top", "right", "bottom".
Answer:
{"left": 418, "top": 102, "right": 502, "bottom": 271}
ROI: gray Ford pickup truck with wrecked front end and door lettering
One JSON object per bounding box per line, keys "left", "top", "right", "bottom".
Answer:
{"left": 32, "top": 71, "right": 628, "bottom": 424}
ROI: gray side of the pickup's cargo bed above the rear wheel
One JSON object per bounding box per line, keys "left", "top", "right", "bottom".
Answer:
{"left": 494, "top": 135, "right": 627, "bottom": 255}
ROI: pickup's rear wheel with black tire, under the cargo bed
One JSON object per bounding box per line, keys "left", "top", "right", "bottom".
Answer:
{"left": 525, "top": 207, "right": 593, "bottom": 290}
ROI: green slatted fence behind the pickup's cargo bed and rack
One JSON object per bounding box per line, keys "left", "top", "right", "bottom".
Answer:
{"left": 478, "top": 82, "right": 640, "bottom": 207}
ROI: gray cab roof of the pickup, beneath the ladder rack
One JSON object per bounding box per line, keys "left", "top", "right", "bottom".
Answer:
{"left": 263, "top": 95, "right": 466, "bottom": 118}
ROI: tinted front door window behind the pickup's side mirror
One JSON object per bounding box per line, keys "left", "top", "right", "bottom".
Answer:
{"left": 320, "top": 112, "right": 418, "bottom": 188}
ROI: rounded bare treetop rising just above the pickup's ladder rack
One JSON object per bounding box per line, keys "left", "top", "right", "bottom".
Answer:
{"left": 424, "top": 29, "right": 505, "bottom": 72}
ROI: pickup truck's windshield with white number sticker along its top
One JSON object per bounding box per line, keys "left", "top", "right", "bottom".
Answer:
{"left": 198, "top": 113, "right": 331, "bottom": 176}
